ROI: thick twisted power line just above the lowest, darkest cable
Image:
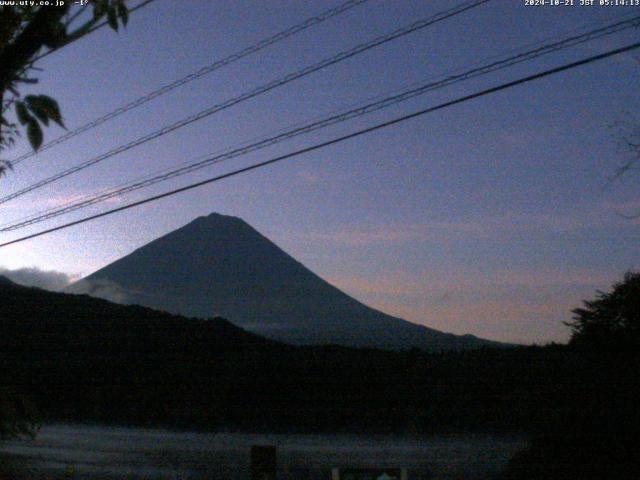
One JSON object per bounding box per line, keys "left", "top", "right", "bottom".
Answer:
{"left": 0, "top": 16, "right": 640, "bottom": 232}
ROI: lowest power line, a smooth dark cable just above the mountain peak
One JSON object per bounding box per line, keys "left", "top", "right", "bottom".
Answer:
{"left": 0, "top": 42, "right": 640, "bottom": 248}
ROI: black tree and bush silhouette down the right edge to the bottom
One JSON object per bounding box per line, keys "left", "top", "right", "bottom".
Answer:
{"left": 502, "top": 272, "right": 640, "bottom": 480}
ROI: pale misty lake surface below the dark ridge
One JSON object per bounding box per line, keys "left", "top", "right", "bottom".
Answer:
{"left": 0, "top": 425, "right": 527, "bottom": 480}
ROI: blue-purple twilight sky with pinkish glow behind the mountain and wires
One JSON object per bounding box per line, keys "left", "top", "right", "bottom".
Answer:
{"left": 0, "top": 0, "right": 640, "bottom": 343}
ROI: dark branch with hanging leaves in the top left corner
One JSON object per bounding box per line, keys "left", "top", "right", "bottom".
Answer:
{"left": 0, "top": 0, "right": 129, "bottom": 176}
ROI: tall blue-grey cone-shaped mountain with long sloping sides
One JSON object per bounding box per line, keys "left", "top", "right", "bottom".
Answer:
{"left": 68, "top": 213, "right": 499, "bottom": 351}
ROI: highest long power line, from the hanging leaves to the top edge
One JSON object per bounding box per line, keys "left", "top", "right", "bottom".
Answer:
{"left": 11, "top": 0, "right": 369, "bottom": 166}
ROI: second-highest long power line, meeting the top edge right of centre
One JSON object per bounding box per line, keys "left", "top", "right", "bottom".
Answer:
{"left": 0, "top": 0, "right": 491, "bottom": 204}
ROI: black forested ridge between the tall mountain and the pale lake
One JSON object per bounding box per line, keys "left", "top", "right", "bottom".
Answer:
{"left": 0, "top": 277, "right": 592, "bottom": 432}
